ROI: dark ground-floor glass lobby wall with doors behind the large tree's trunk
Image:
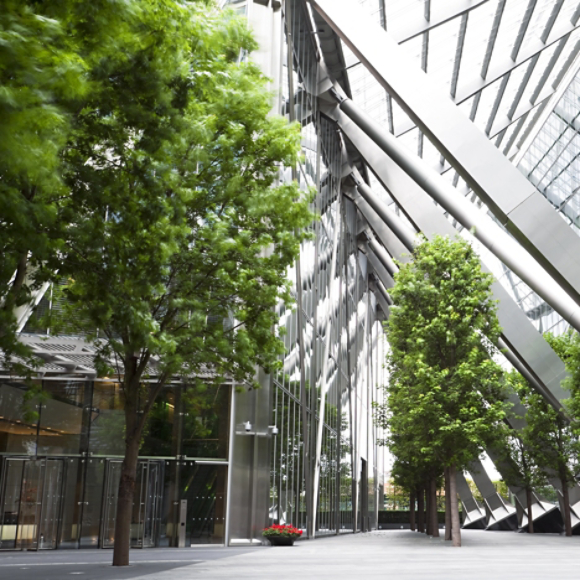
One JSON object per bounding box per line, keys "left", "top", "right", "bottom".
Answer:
{"left": 0, "top": 379, "right": 231, "bottom": 550}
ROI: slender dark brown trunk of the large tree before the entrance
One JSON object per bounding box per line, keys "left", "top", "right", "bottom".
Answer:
{"left": 113, "top": 402, "right": 143, "bottom": 566}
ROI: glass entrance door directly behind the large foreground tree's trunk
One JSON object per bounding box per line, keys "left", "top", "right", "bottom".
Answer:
{"left": 101, "top": 460, "right": 163, "bottom": 548}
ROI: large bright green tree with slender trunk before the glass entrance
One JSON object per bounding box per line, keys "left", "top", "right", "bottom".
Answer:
{"left": 2, "top": 0, "right": 313, "bottom": 566}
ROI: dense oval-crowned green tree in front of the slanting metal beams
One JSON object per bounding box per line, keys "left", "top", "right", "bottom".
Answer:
{"left": 376, "top": 237, "right": 505, "bottom": 546}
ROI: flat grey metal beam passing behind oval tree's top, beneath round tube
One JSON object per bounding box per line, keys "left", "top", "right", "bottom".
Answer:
{"left": 326, "top": 102, "right": 568, "bottom": 404}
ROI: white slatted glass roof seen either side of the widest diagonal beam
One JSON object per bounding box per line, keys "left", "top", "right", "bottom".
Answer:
{"left": 343, "top": 0, "right": 580, "bottom": 171}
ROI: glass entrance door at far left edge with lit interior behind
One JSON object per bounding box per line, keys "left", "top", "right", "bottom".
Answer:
{"left": 0, "top": 457, "right": 66, "bottom": 550}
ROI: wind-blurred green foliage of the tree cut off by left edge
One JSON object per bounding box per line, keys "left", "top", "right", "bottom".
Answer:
{"left": 0, "top": 0, "right": 87, "bottom": 370}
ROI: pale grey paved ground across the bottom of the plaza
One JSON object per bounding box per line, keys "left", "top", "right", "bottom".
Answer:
{"left": 0, "top": 531, "right": 580, "bottom": 580}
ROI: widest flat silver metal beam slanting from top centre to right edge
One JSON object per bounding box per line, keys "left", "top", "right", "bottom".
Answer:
{"left": 310, "top": 0, "right": 580, "bottom": 306}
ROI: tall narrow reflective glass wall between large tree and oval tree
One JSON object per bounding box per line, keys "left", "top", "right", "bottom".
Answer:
{"left": 269, "top": 0, "right": 382, "bottom": 535}
